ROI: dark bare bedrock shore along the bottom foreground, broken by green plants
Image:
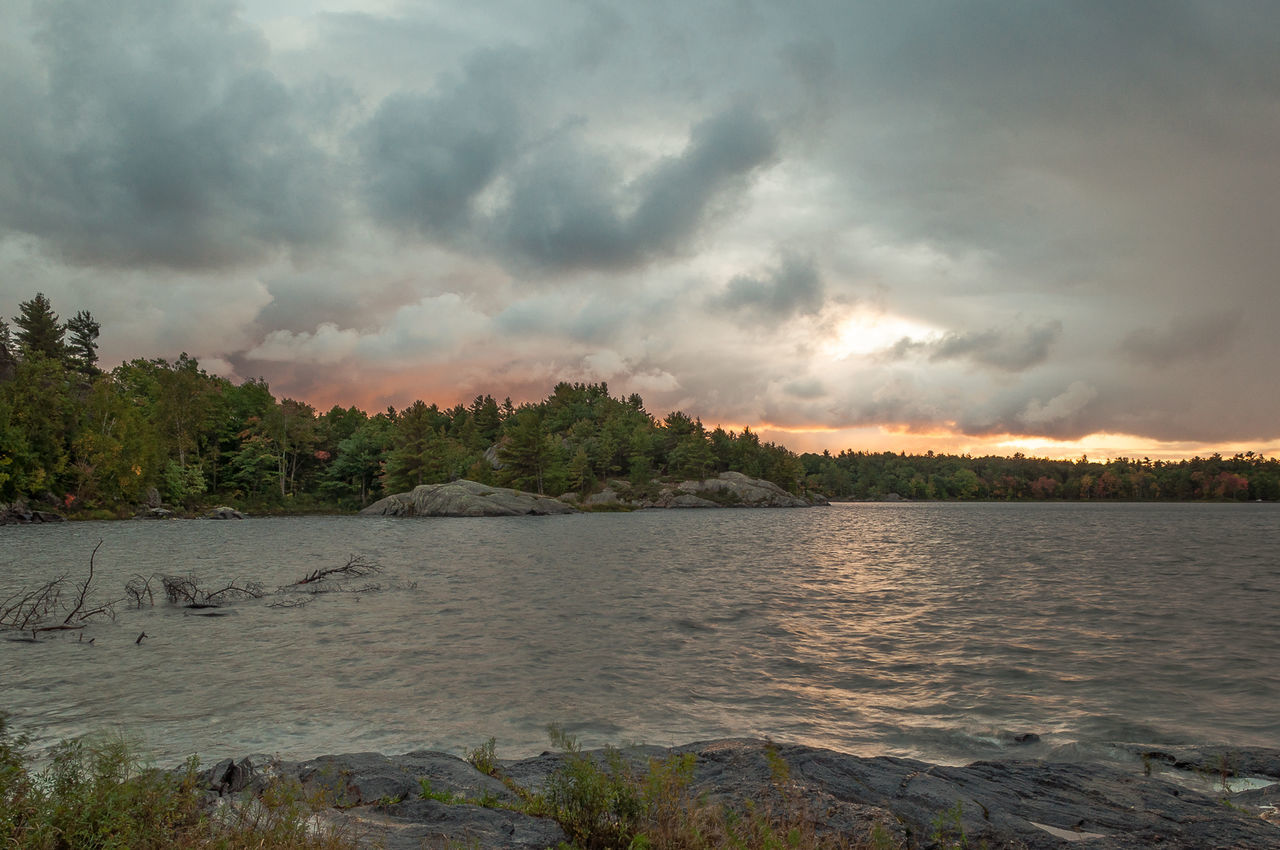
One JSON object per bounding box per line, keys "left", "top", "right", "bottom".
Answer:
{"left": 202, "top": 739, "right": 1280, "bottom": 850}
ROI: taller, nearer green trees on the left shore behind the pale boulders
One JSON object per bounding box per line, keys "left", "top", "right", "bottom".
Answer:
{"left": 0, "top": 294, "right": 804, "bottom": 513}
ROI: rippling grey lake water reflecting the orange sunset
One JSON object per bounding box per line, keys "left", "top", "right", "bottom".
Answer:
{"left": 0, "top": 504, "right": 1280, "bottom": 762}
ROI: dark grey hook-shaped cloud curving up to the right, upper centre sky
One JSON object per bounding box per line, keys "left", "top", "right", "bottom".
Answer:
{"left": 493, "top": 108, "right": 778, "bottom": 270}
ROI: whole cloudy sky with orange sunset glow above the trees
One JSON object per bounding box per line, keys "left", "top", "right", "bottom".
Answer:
{"left": 0, "top": 0, "right": 1280, "bottom": 457}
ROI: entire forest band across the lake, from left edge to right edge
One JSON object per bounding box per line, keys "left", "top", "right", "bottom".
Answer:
{"left": 0, "top": 293, "right": 1280, "bottom": 517}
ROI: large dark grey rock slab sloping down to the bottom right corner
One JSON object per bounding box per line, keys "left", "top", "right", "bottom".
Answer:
{"left": 681, "top": 741, "right": 1280, "bottom": 850}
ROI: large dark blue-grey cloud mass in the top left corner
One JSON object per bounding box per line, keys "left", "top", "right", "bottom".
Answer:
{"left": 0, "top": 0, "right": 337, "bottom": 268}
